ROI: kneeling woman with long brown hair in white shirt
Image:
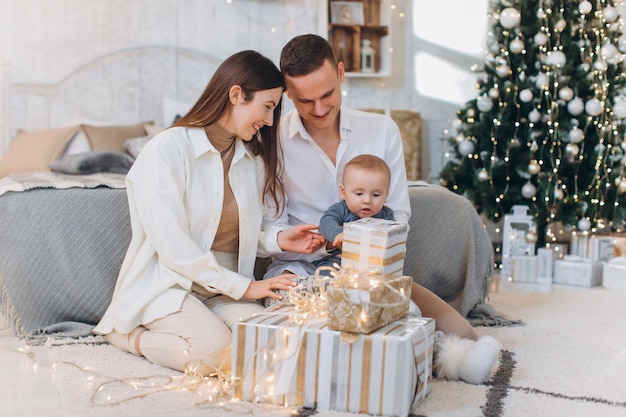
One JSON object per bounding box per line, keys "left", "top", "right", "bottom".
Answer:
{"left": 95, "top": 51, "right": 323, "bottom": 375}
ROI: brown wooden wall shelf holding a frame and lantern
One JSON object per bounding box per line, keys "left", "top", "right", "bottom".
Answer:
{"left": 326, "top": 0, "right": 391, "bottom": 77}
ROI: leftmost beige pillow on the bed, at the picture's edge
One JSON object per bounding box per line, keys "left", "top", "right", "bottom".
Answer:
{"left": 0, "top": 122, "right": 80, "bottom": 178}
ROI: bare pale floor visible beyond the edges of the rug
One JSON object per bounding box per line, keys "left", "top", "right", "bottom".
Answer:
{"left": 0, "top": 275, "right": 576, "bottom": 417}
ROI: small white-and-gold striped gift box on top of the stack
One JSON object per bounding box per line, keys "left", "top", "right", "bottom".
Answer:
{"left": 341, "top": 217, "right": 408, "bottom": 275}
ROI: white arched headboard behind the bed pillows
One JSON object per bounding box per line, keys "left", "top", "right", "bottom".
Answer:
{"left": 0, "top": 45, "right": 223, "bottom": 154}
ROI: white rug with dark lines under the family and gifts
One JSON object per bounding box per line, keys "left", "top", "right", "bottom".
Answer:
{"left": 12, "top": 287, "right": 626, "bottom": 417}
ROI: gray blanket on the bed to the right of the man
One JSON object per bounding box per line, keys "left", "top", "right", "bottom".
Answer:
{"left": 404, "top": 185, "right": 494, "bottom": 316}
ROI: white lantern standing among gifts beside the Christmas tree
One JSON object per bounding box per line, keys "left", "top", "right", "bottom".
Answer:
{"left": 502, "top": 205, "right": 537, "bottom": 278}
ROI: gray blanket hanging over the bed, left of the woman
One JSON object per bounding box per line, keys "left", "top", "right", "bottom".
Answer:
{"left": 0, "top": 187, "right": 130, "bottom": 338}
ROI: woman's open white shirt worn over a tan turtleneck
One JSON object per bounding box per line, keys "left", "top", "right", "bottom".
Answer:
{"left": 95, "top": 127, "right": 280, "bottom": 333}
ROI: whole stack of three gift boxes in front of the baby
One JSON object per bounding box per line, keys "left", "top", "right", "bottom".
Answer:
{"left": 231, "top": 218, "right": 428, "bottom": 416}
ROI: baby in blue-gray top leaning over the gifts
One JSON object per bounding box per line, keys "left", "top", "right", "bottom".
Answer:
{"left": 315, "top": 154, "right": 395, "bottom": 266}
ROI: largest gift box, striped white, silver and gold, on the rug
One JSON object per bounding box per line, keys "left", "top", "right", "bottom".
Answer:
{"left": 232, "top": 304, "right": 435, "bottom": 416}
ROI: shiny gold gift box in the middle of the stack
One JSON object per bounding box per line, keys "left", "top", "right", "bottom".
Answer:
{"left": 326, "top": 269, "right": 413, "bottom": 334}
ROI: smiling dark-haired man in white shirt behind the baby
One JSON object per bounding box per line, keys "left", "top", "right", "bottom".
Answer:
{"left": 266, "top": 35, "right": 411, "bottom": 277}
